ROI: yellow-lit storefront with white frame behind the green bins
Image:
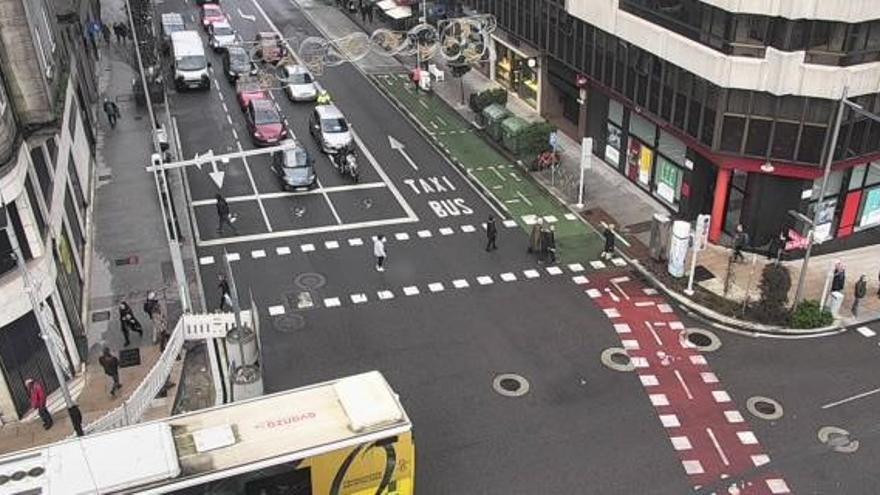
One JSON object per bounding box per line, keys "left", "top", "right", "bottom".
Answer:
{"left": 489, "top": 33, "right": 541, "bottom": 112}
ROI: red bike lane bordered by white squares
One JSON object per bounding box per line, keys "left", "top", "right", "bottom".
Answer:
{"left": 580, "top": 273, "right": 791, "bottom": 495}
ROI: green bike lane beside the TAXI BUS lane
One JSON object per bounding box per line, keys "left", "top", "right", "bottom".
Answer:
{"left": 372, "top": 74, "right": 603, "bottom": 263}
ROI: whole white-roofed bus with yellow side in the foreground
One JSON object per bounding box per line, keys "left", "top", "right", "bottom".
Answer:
{"left": 0, "top": 371, "right": 415, "bottom": 495}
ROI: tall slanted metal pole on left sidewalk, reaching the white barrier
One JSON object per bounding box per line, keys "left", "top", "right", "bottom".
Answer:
{"left": 125, "top": 0, "right": 191, "bottom": 311}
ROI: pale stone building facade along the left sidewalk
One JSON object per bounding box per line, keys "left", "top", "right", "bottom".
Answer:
{"left": 0, "top": 0, "right": 98, "bottom": 420}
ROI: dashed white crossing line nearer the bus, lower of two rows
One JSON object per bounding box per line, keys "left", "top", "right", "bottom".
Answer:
{"left": 268, "top": 263, "right": 589, "bottom": 316}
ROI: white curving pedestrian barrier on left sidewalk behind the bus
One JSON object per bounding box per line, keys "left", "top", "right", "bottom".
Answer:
{"left": 83, "top": 311, "right": 251, "bottom": 434}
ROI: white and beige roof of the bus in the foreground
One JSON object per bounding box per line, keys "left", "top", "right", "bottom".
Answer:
{"left": 0, "top": 371, "right": 412, "bottom": 495}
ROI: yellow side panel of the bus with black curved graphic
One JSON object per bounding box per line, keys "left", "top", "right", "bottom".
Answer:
{"left": 303, "top": 432, "right": 415, "bottom": 495}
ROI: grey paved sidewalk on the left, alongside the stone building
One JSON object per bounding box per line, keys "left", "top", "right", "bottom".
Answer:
{"left": 0, "top": 0, "right": 211, "bottom": 453}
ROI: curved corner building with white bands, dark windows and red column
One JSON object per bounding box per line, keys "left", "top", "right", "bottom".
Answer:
{"left": 466, "top": 0, "right": 880, "bottom": 251}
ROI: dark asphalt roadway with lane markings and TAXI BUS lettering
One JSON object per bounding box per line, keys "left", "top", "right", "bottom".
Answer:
{"left": 158, "top": 0, "right": 880, "bottom": 494}
